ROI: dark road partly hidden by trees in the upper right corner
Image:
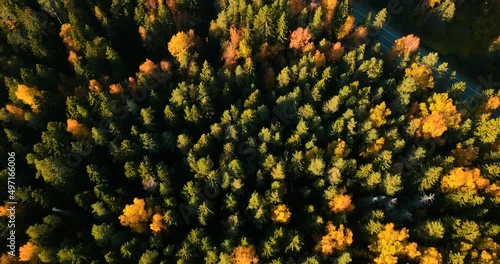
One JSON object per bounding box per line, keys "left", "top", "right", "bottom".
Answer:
{"left": 352, "top": 1, "right": 482, "bottom": 99}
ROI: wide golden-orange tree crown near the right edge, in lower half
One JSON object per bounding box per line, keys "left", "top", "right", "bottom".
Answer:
{"left": 441, "top": 167, "right": 490, "bottom": 194}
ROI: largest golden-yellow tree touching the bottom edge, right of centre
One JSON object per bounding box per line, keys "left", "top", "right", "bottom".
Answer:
{"left": 368, "top": 223, "right": 421, "bottom": 264}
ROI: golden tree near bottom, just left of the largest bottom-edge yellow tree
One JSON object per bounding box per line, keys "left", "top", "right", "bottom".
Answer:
{"left": 315, "top": 222, "right": 353, "bottom": 256}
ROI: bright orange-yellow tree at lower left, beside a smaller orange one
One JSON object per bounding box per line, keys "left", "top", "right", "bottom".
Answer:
{"left": 118, "top": 198, "right": 152, "bottom": 233}
